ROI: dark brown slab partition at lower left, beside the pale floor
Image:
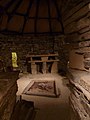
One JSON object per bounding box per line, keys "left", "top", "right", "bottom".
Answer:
{"left": 0, "top": 72, "right": 18, "bottom": 120}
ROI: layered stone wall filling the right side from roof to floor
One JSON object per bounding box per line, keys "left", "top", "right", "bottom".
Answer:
{"left": 62, "top": 0, "right": 90, "bottom": 120}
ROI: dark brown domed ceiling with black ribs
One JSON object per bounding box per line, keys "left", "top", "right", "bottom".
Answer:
{"left": 0, "top": 0, "right": 64, "bottom": 35}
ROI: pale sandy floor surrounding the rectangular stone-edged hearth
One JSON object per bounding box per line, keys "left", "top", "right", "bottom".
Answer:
{"left": 17, "top": 74, "right": 70, "bottom": 120}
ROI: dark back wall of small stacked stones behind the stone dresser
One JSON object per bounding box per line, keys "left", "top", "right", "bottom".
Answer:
{"left": 0, "top": 35, "right": 65, "bottom": 71}
